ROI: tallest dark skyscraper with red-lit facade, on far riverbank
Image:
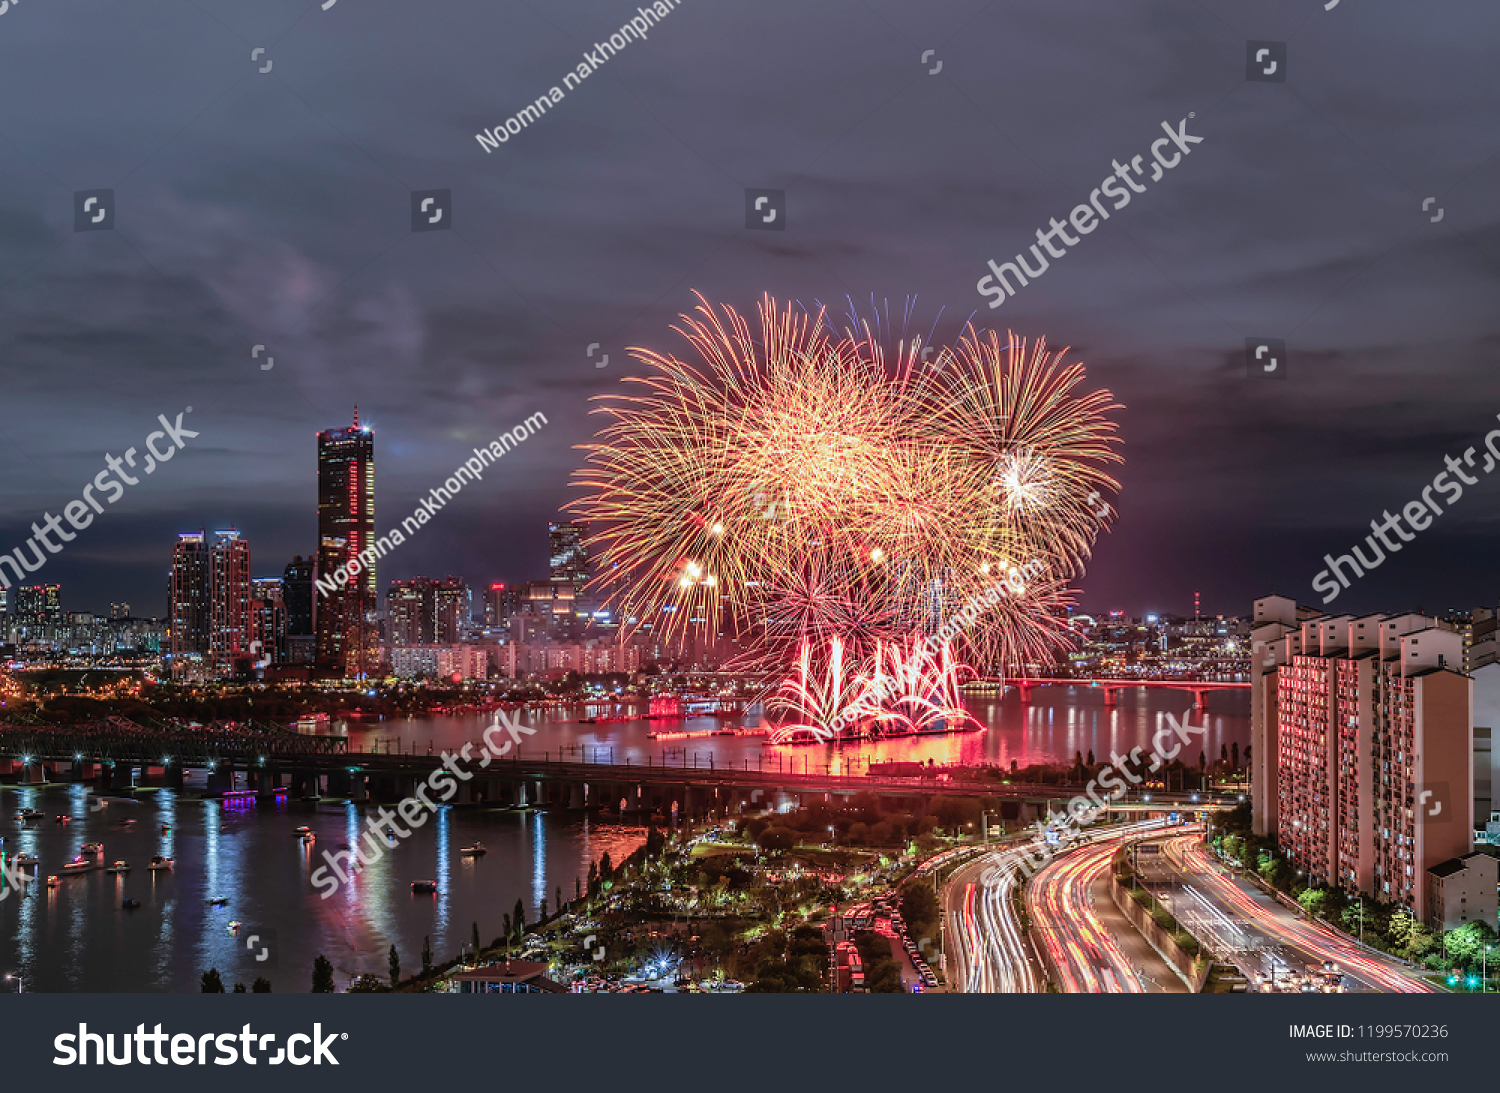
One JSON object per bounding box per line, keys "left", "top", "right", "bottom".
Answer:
{"left": 315, "top": 409, "right": 380, "bottom": 678}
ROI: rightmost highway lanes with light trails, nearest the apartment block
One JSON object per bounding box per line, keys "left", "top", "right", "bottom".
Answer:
{"left": 1140, "top": 837, "right": 1436, "bottom": 994}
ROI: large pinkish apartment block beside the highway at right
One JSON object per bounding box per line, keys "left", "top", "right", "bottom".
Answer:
{"left": 1251, "top": 597, "right": 1475, "bottom": 921}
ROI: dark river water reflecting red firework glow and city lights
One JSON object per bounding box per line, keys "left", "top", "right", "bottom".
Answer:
{"left": 0, "top": 687, "right": 1250, "bottom": 991}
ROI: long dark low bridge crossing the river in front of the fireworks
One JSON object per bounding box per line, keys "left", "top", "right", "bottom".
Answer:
{"left": 0, "top": 726, "right": 1214, "bottom": 819}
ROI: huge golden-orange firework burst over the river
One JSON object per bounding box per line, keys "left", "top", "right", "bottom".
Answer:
{"left": 570, "top": 297, "right": 1119, "bottom": 724}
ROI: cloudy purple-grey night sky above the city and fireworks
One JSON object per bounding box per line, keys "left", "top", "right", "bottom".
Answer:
{"left": 0, "top": 0, "right": 1500, "bottom": 615}
